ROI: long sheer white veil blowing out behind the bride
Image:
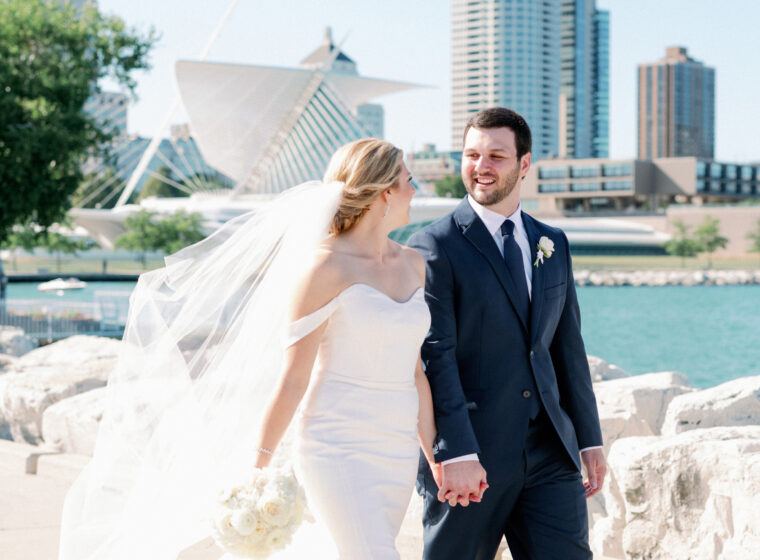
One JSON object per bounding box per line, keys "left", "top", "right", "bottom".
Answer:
{"left": 59, "top": 182, "right": 342, "bottom": 560}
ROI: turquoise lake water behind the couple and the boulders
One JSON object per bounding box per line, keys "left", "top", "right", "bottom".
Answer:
{"left": 8, "top": 282, "right": 760, "bottom": 388}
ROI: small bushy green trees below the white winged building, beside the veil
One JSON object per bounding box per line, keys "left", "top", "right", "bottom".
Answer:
{"left": 115, "top": 210, "right": 205, "bottom": 266}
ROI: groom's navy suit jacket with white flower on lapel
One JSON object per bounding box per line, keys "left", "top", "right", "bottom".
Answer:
{"left": 409, "top": 200, "right": 602, "bottom": 482}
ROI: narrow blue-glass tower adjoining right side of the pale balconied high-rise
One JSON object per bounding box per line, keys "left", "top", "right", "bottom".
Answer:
{"left": 559, "top": 0, "right": 609, "bottom": 158}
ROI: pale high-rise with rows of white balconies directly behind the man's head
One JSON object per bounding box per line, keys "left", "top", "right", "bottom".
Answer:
{"left": 451, "top": 0, "right": 560, "bottom": 159}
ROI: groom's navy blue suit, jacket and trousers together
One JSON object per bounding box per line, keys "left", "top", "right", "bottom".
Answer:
{"left": 409, "top": 200, "right": 602, "bottom": 560}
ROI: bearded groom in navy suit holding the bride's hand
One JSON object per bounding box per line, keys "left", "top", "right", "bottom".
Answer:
{"left": 409, "top": 108, "right": 606, "bottom": 560}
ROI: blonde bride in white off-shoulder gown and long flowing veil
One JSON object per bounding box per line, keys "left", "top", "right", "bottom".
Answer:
{"left": 59, "top": 139, "right": 435, "bottom": 560}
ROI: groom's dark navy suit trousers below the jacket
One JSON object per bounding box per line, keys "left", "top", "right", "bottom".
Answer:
{"left": 423, "top": 412, "right": 592, "bottom": 560}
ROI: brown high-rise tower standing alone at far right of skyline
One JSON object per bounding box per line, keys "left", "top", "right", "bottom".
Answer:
{"left": 638, "top": 47, "right": 715, "bottom": 159}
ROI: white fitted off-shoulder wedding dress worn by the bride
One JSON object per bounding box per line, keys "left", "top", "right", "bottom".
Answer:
{"left": 288, "top": 284, "right": 430, "bottom": 560}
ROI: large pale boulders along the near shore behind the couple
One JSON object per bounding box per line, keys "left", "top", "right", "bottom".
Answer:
{"left": 0, "top": 330, "right": 760, "bottom": 560}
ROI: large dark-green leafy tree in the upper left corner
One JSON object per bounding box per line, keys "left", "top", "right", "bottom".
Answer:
{"left": 0, "top": 0, "right": 155, "bottom": 241}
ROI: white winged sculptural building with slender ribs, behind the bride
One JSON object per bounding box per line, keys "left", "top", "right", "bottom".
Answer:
{"left": 71, "top": 28, "right": 455, "bottom": 248}
